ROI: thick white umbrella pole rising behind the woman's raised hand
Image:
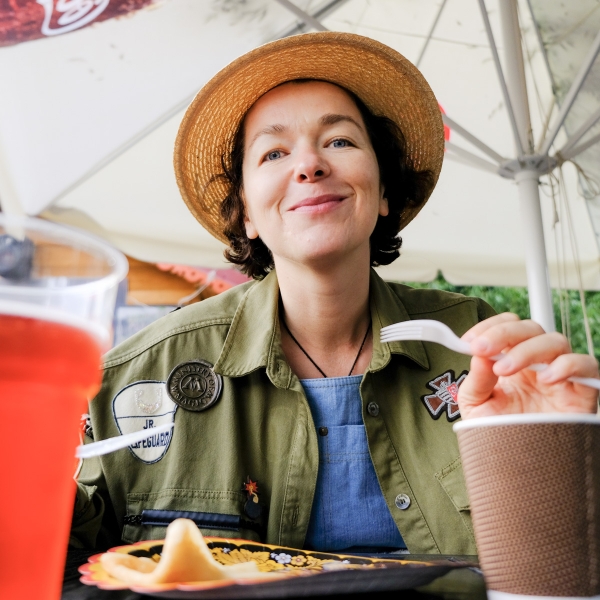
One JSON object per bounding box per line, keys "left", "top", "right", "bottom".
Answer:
{"left": 499, "top": 0, "right": 556, "bottom": 332}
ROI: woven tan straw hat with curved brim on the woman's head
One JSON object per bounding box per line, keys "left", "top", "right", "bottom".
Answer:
{"left": 174, "top": 32, "right": 444, "bottom": 243}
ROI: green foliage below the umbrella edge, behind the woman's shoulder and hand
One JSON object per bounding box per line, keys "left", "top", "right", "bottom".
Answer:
{"left": 408, "top": 274, "right": 600, "bottom": 360}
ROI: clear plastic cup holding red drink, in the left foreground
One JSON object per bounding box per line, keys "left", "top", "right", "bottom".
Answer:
{"left": 0, "top": 214, "right": 127, "bottom": 600}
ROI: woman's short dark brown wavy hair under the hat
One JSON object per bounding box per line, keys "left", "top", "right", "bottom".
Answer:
{"left": 221, "top": 80, "right": 435, "bottom": 279}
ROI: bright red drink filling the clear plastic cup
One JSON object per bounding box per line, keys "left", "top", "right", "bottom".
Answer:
{"left": 0, "top": 308, "right": 102, "bottom": 600}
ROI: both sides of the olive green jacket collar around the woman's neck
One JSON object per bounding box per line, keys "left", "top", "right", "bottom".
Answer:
{"left": 214, "top": 270, "right": 429, "bottom": 388}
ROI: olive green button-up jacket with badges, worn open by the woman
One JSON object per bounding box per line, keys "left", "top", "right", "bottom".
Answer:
{"left": 71, "top": 271, "right": 493, "bottom": 554}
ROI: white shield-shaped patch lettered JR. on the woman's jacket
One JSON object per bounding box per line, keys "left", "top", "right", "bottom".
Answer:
{"left": 113, "top": 381, "right": 177, "bottom": 464}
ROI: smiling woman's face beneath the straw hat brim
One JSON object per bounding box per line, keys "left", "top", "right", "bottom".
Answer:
{"left": 243, "top": 81, "right": 388, "bottom": 265}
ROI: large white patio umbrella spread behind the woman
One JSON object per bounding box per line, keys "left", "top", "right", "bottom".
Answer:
{"left": 0, "top": 0, "right": 600, "bottom": 329}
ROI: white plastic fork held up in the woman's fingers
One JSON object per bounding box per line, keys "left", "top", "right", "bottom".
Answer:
{"left": 381, "top": 319, "right": 600, "bottom": 390}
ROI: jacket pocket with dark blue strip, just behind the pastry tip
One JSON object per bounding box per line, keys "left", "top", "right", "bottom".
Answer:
{"left": 122, "top": 489, "right": 266, "bottom": 543}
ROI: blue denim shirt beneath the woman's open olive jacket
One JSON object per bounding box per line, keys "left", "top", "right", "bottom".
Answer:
{"left": 301, "top": 375, "right": 406, "bottom": 551}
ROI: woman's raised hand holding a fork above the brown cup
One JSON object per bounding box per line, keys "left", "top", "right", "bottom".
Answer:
{"left": 458, "top": 313, "right": 598, "bottom": 419}
